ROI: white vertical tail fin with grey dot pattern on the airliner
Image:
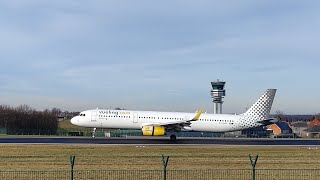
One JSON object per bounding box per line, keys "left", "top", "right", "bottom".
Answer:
{"left": 241, "top": 89, "right": 277, "bottom": 128}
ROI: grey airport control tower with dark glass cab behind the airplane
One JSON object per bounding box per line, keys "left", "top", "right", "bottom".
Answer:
{"left": 211, "top": 79, "right": 226, "bottom": 114}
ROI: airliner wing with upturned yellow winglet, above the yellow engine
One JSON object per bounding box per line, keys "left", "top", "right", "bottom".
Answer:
{"left": 142, "top": 111, "right": 202, "bottom": 131}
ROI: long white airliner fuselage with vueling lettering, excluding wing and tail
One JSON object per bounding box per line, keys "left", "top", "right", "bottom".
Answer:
{"left": 71, "top": 109, "right": 245, "bottom": 132}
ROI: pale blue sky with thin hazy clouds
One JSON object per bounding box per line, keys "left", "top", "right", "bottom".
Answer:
{"left": 0, "top": 0, "right": 320, "bottom": 114}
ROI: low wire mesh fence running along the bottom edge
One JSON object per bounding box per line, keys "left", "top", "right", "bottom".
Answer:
{"left": 0, "top": 169, "right": 320, "bottom": 180}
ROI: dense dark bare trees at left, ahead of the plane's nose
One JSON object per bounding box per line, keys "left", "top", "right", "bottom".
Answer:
{"left": 0, "top": 105, "right": 58, "bottom": 135}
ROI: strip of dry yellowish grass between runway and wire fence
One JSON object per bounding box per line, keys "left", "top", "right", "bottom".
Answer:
{"left": 0, "top": 145, "right": 320, "bottom": 170}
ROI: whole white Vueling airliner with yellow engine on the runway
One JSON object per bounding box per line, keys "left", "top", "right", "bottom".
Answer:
{"left": 70, "top": 89, "right": 277, "bottom": 141}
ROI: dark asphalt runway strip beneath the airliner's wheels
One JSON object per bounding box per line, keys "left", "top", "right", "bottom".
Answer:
{"left": 0, "top": 137, "right": 320, "bottom": 146}
